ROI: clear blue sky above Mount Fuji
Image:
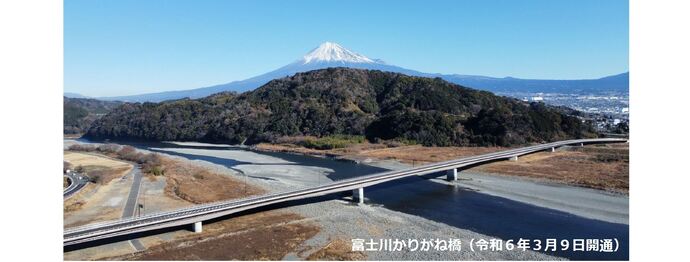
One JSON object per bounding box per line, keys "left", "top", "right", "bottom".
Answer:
{"left": 64, "top": 0, "right": 628, "bottom": 96}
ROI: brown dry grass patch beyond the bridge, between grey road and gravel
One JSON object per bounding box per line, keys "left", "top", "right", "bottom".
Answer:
{"left": 158, "top": 158, "right": 265, "bottom": 204}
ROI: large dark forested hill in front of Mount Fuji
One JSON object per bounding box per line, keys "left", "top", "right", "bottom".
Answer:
{"left": 86, "top": 68, "right": 595, "bottom": 146}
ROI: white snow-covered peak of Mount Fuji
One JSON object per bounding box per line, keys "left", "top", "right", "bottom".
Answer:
{"left": 302, "top": 42, "right": 378, "bottom": 64}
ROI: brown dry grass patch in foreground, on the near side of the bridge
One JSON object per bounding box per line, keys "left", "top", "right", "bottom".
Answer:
{"left": 108, "top": 211, "right": 320, "bottom": 260}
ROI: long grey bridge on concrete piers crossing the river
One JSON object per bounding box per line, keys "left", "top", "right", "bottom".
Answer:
{"left": 63, "top": 138, "right": 628, "bottom": 246}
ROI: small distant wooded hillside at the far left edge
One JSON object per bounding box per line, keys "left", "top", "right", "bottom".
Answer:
{"left": 62, "top": 97, "right": 122, "bottom": 134}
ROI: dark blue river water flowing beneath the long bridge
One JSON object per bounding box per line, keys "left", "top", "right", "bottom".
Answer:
{"left": 68, "top": 140, "right": 629, "bottom": 260}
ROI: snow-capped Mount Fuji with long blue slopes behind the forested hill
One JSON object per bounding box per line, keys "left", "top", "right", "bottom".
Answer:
{"left": 98, "top": 42, "right": 628, "bottom": 102}
